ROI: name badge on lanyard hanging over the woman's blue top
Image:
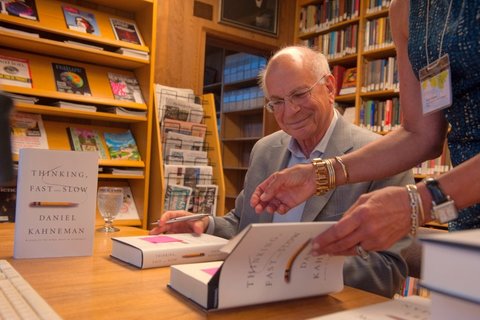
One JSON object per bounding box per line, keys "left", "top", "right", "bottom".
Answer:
{"left": 419, "top": 0, "right": 453, "bottom": 115}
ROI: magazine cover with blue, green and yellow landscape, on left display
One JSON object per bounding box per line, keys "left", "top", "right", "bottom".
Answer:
{"left": 103, "top": 130, "right": 140, "bottom": 161}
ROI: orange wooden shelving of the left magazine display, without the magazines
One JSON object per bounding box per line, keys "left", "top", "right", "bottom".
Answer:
{"left": 0, "top": 0, "right": 157, "bottom": 228}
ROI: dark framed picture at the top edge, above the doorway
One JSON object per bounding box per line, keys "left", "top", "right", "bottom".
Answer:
{"left": 220, "top": 0, "right": 278, "bottom": 36}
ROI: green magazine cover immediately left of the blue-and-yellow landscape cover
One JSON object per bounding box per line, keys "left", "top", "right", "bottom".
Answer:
{"left": 67, "top": 127, "right": 108, "bottom": 159}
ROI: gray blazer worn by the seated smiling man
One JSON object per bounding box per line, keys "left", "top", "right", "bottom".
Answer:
{"left": 213, "top": 116, "right": 414, "bottom": 297}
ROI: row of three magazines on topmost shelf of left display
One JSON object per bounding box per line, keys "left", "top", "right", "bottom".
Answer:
{"left": 0, "top": 0, "right": 144, "bottom": 45}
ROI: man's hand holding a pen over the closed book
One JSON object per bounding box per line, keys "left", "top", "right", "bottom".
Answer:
{"left": 149, "top": 210, "right": 209, "bottom": 234}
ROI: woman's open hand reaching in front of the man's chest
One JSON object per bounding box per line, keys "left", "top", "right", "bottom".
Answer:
{"left": 250, "top": 164, "right": 316, "bottom": 214}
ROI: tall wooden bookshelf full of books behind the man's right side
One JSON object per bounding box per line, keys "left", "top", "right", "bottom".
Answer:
{"left": 295, "top": 0, "right": 450, "bottom": 179}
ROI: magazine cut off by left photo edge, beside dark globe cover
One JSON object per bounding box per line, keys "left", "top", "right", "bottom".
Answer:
{"left": 0, "top": 55, "right": 32, "bottom": 88}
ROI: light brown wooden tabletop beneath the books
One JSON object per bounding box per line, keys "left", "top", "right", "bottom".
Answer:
{"left": 0, "top": 223, "right": 387, "bottom": 320}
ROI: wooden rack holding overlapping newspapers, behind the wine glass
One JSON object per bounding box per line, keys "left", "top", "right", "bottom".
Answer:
{"left": 149, "top": 84, "right": 225, "bottom": 223}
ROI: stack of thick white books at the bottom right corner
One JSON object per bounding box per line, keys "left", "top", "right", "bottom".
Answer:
{"left": 421, "top": 229, "right": 480, "bottom": 319}
